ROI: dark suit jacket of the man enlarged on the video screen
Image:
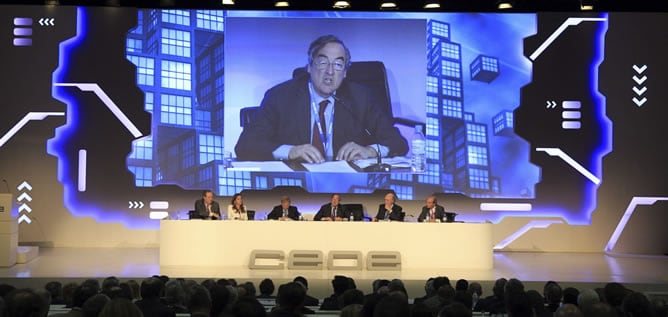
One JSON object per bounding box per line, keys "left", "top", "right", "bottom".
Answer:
{"left": 235, "top": 76, "right": 408, "bottom": 161}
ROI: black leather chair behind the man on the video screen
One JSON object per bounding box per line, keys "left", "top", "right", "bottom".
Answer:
{"left": 239, "top": 61, "right": 425, "bottom": 133}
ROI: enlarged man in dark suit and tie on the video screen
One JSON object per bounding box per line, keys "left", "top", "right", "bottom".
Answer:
{"left": 235, "top": 35, "right": 408, "bottom": 163}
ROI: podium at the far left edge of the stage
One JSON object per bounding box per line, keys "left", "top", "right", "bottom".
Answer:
{"left": 0, "top": 193, "right": 19, "bottom": 267}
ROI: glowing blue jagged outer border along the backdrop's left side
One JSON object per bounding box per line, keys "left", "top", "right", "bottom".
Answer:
{"left": 47, "top": 7, "right": 160, "bottom": 229}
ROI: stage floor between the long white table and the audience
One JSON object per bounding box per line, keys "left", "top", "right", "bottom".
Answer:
{"left": 0, "top": 248, "right": 668, "bottom": 296}
